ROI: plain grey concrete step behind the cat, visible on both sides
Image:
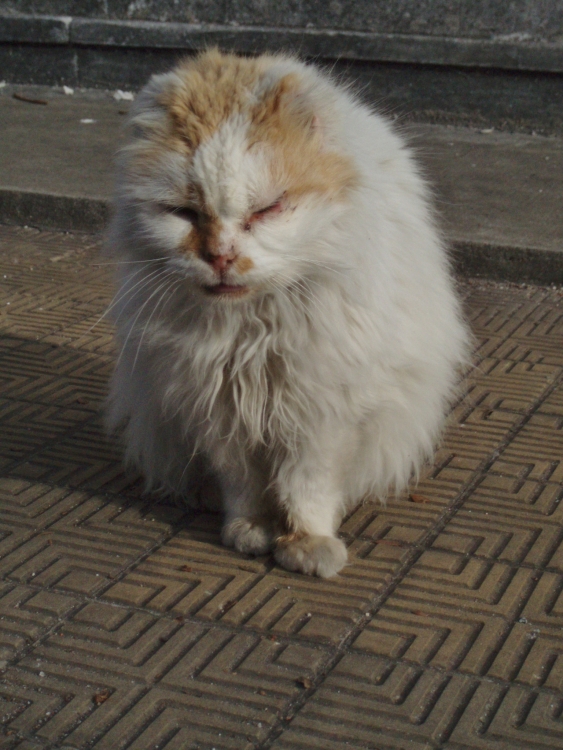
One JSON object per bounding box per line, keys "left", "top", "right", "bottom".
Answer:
{"left": 0, "top": 86, "right": 563, "bottom": 284}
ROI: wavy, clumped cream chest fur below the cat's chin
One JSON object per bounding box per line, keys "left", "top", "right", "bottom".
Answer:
{"left": 173, "top": 308, "right": 318, "bottom": 450}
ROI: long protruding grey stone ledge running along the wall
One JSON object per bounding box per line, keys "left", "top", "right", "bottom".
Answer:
{"left": 0, "top": 14, "right": 563, "bottom": 73}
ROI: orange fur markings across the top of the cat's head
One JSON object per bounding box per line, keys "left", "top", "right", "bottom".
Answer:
{"left": 160, "top": 49, "right": 358, "bottom": 200}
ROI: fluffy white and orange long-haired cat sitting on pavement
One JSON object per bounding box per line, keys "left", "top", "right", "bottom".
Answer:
{"left": 108, "top": 50, "right": 469, "bottom": 577}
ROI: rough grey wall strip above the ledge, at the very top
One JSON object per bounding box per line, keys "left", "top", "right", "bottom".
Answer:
{"left": 0, "top": 0, "right": 563, "bottom": 43}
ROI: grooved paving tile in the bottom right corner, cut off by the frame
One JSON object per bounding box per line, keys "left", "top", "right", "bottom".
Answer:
{"left": 272, "top": 655, "right": 563, "bottom": 750}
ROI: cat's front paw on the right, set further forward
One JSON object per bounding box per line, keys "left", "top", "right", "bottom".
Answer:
{"left": 274, "top": 534, "right": 348, "bottom": 578}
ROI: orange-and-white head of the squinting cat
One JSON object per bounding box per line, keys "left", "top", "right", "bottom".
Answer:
{"left": 116, "top": 50, "right": 358, "bottom": 301}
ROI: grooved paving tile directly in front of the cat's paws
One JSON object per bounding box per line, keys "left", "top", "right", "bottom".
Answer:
{"left": 103, "top": 519, "right": 384, "bottom": 643}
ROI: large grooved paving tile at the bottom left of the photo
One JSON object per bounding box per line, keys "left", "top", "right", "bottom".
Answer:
{"left": 0, "top": 603, "right": 327, "bottom": 748}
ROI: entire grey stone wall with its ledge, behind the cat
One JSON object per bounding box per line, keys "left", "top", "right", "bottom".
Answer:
{"left": 0, "top": 0, "right": 563, "bottom": 133}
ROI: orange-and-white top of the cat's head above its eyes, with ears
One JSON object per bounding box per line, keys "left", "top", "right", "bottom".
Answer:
{"left": 128, "top": 50, "right": 358, "bottom": 206}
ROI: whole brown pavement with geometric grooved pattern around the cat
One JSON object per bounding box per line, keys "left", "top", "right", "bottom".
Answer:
{"left": 0, "top": 227, "right": 563, "bottom": 750}
